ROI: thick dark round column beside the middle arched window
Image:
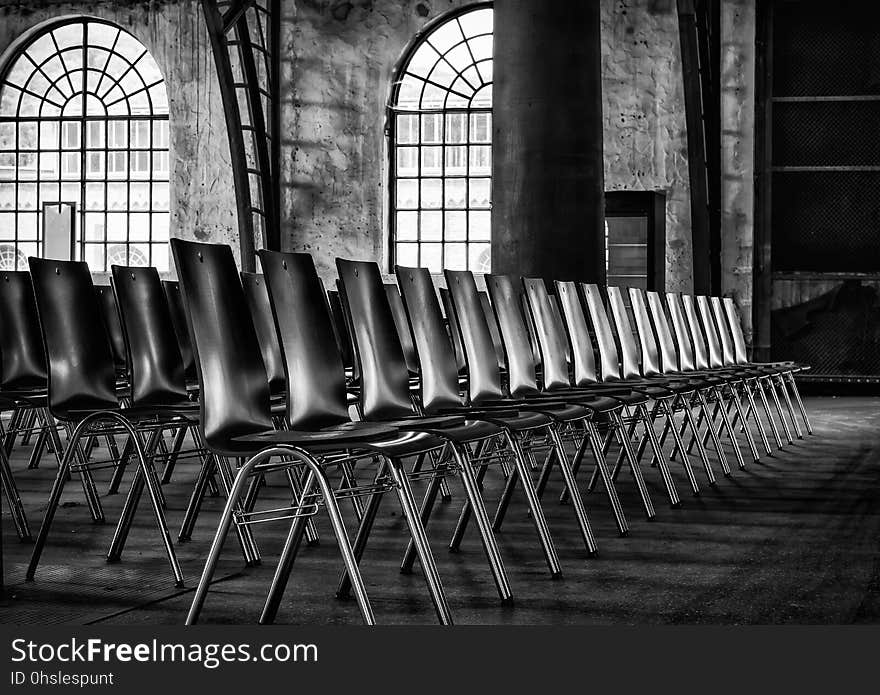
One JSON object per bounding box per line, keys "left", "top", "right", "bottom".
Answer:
{"left": 492, "top": 0, "right": 605, "bottom": 283}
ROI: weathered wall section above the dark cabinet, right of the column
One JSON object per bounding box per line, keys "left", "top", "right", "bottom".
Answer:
{"left": 602, "top": 0, "right": 693, "bottom": 291}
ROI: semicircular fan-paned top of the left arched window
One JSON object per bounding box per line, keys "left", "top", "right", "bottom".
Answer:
{"left": 0, "top": 18, "right": 168, "bottom": 118}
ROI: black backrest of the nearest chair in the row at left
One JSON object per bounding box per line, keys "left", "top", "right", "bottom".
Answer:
{"left": 28, "top": 257, "right": 119, "bottom": 419}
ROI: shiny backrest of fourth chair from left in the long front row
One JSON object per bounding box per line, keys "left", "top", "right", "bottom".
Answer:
{"left": 394, "top": 265, "right": 463, "bottom": 413}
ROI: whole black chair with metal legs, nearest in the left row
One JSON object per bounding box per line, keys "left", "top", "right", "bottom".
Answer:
{"left": 27, "top": 258, "right": 183, "bottom": 586}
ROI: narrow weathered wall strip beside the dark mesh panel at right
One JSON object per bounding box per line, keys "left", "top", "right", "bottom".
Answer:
{"left": 721, "top": 0, "right": 755, "bottom": 339}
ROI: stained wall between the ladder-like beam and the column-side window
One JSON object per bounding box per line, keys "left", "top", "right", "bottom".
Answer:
{"left": 281, "top": 0, "right": 474, "bottom": 278}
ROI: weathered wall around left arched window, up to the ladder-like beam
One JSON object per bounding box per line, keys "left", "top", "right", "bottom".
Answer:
{"left": 0, "top": 0, "right": 238, "bottom": 266}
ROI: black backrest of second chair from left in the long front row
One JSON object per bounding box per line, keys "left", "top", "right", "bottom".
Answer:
{"left": 259, "top": 250, "right": 349, "bottom": 430}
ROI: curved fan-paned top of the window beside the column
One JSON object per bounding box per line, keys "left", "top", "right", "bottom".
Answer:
{"left": 391, "top": 6, "right": 493, "bottom": 111}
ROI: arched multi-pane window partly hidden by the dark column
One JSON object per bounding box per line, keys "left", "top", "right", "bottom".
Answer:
{"left": 389, "top": 3, "right": 492, "bottom": 272}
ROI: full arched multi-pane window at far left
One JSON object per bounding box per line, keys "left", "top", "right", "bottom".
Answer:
{"left": 0, "top": 18, "right": 170, "bottom": 270}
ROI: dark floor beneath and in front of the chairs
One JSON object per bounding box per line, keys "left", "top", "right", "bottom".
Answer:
{"left": 0, "top": 397, "right": 880, "bottom": 624}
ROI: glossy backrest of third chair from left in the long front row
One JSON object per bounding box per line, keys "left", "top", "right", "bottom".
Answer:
{"left": 336, "top": 258, "right": 413, "bottom": 420}
